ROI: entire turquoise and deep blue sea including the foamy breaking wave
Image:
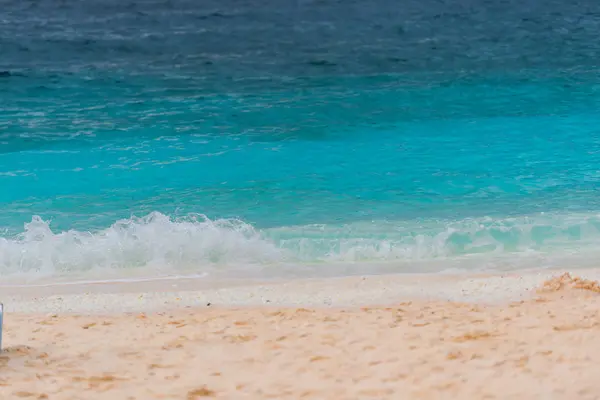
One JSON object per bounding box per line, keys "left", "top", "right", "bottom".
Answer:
{"left": 0, "top": 0, "right": 600, "bottom": 284}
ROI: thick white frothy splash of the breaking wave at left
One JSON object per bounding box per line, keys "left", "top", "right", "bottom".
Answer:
{"left": 0, "top": 212, "right": 282, "bottom": 276}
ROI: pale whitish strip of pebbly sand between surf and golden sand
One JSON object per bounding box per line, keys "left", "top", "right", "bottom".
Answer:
{"left": 0, "top": 268, "right": 600, "bottom": 314}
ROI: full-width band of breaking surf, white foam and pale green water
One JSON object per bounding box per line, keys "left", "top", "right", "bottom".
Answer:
{"left": 0, "top": 212, "right": 600, "bottom": 285}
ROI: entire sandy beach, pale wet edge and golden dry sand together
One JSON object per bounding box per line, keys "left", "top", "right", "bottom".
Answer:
{"left": 0, "top": 270, "right": 600, "bottom": 400}
